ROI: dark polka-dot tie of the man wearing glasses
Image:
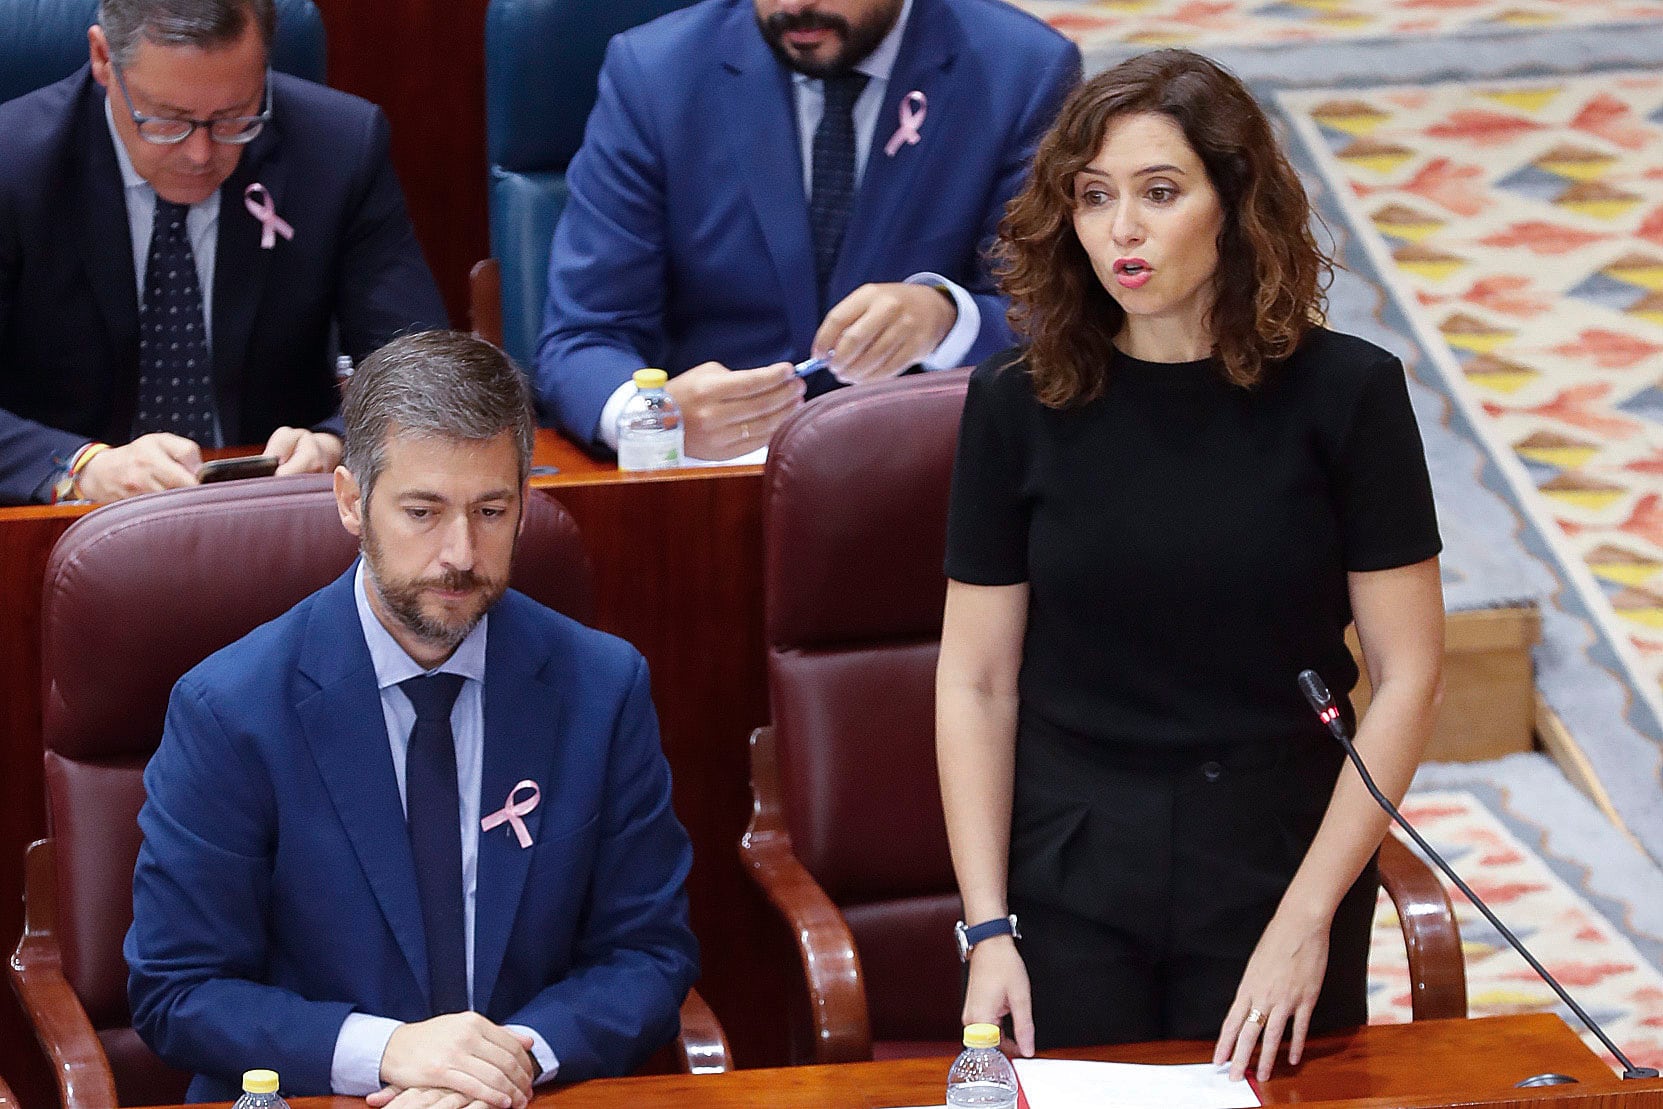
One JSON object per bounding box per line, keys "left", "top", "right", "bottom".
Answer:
{"left": 133, "top": 196, "right": 218, "bottom": 446}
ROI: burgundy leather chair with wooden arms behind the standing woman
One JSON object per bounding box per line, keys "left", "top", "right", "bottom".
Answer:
{"left": 740, "top": 371, "right": 1467, "bottom": 1062}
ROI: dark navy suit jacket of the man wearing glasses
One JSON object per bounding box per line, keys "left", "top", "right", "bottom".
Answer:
{"left": 0, "top": 67, "right": 446, "bottom": 504}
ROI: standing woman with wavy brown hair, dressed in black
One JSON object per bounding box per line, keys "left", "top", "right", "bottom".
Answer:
{"left": 936, "top": 50, "right": 1443, "bottom": 1079}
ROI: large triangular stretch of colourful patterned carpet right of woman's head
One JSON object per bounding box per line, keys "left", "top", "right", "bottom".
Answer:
{"left": 1277, "top": 71, "right": 1663, "bottom": 860}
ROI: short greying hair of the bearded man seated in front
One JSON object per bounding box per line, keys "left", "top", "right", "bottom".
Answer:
{"left": 341, "top": 331, "right": 537, "bottom": 504}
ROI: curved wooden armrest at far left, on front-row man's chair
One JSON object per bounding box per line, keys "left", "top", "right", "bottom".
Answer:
{"left": 7, "top": 840, "right": 118, "bottom": 1109}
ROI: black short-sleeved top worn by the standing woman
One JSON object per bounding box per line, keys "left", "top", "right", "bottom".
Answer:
{"left": 946, "top": 329, "right": 1442, "bottom": 747}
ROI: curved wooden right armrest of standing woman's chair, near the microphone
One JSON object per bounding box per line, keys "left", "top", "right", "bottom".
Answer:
{"left": 1380, "top": 833, "right": 1467, "bottom": 1021}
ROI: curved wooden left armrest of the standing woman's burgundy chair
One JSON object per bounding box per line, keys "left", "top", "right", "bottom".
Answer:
{"left": 738, "top": 727, "right": 871, "bottom": 1062}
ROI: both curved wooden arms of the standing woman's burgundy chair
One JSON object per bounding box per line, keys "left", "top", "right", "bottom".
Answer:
{"left": 738, "top": 727, "right": 1467, "bottom": 1062}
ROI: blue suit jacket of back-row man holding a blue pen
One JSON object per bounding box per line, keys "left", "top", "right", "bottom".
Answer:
{"left": 535, "top": 0, "right": 1079, "bottom": 442}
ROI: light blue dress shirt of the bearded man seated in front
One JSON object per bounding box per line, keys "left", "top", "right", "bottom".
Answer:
{"left": 329, "top": 560, "right": 560, "bottom": 1097}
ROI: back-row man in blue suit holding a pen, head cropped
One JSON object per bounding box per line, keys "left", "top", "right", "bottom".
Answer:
{"left": 537, "top": 0, "right": 1079, "bottom": 459}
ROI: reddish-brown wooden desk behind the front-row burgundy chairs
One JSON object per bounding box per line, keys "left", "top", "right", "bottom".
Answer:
{"left": 0, "top": 431, "right": 797, "bottom": 1106}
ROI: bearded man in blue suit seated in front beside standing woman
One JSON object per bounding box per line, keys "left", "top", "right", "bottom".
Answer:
{"left": 126, "top": 333, "right": 698, "bottom": 1109}
